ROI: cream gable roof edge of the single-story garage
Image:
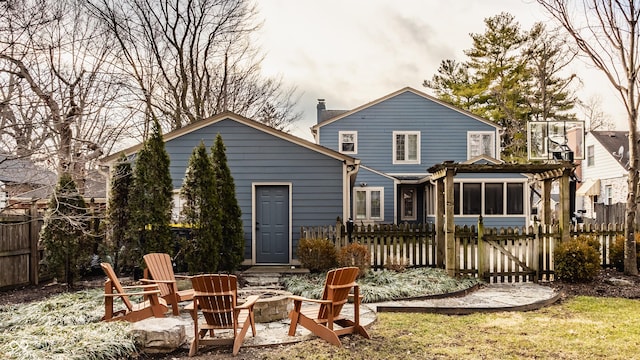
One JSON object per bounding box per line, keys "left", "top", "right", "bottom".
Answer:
{"left": 102, "top": 111, "right": 359, "bottom": 164}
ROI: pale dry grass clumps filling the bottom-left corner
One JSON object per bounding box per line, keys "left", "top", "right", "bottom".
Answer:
{"left": 0, "top": 289, "right": 136, "bottom": 359}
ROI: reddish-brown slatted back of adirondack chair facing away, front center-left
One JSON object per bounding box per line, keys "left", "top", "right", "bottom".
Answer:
{"left": 191, "top": 274, "right": 238, "bottom": 329}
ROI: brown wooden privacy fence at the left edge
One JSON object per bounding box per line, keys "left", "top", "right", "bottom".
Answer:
{"left": 0, "top": 212, "right": 42, "bottom": 288}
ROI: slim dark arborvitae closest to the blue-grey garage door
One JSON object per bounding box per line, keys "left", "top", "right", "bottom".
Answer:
{"left": 212, "top": 134, "right": 244, "bottom": 272}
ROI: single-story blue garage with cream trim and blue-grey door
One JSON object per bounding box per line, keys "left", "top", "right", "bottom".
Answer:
{"left": 103, "top": 112, "right": 359, "bottom": 265}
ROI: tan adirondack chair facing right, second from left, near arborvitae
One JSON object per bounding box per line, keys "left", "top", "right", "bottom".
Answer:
{"left": 142, "top": 253, "right": 193, "bottom": 316}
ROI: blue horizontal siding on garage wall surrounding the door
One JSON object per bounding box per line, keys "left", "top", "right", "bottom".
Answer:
{"left": 166, "top": 119, "right": 343, "bottom": 259}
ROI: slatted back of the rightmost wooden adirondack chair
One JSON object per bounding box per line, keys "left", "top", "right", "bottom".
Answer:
{"left": 318, "top": 267, "right": 360, "bottom": 319}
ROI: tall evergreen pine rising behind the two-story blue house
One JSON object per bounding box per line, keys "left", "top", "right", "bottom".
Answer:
{"left": 424, "top": 13, "right": 575, "bottom": 160}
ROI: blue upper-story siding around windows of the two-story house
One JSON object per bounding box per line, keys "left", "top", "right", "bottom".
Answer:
{"left": 318, "top": 91, "right": 495, "bottom": 174}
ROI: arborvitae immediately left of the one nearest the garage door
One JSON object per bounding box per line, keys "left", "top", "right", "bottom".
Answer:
{"left": 181, "top": 142, "right": 222, "bottom": 273}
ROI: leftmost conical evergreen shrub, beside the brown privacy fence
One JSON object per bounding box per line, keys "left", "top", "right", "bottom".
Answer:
{"left": 40, "top": 173, "right": 93, "bottom": 287}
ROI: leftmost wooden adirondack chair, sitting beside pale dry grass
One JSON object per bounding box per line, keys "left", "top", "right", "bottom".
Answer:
{"left": 100, "top": 263, "right": 168, "bottom": 322}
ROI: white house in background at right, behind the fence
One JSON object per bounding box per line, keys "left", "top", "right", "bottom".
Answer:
{"left": 576, "top": 131, "right": 629, "bottom": 218}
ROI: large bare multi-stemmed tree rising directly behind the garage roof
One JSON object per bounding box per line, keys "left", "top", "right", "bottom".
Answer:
{"left": 89, "top": 0, "right": 301, "bottom": 134}
